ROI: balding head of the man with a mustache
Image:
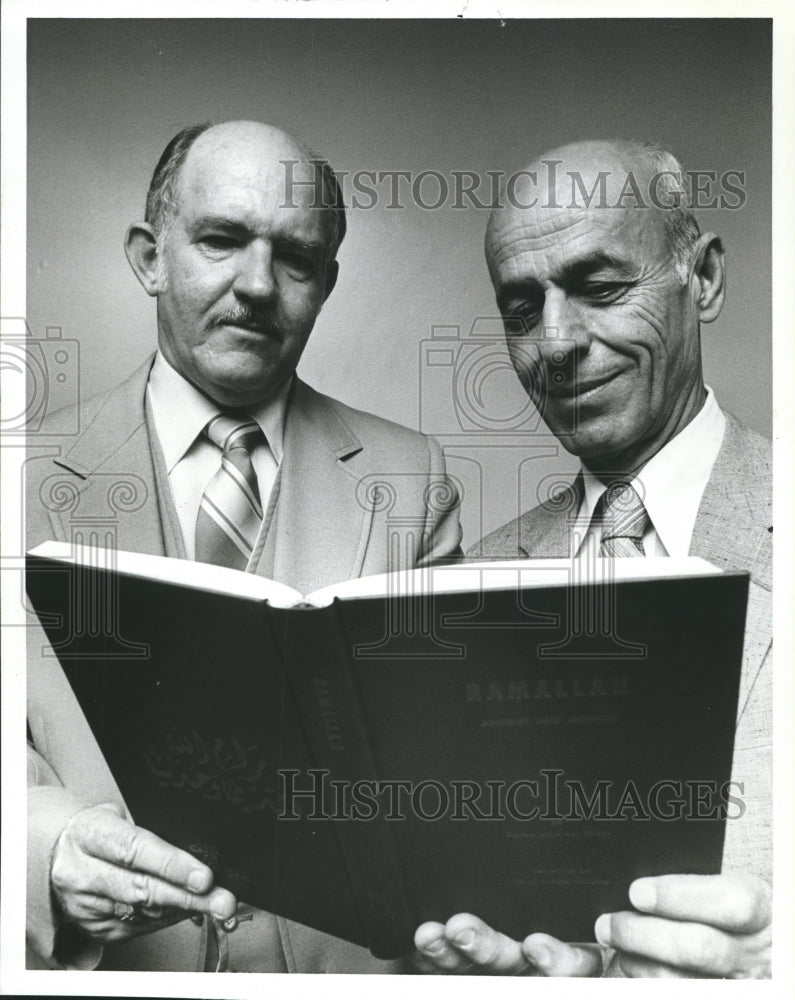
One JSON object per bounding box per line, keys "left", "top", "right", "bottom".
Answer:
{"left": 125, "top": 121, "right": 344, "bottom": 408}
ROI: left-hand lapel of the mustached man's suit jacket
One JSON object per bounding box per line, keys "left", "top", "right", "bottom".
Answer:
{"left": 48, "top": 358, "right": 165, "bottom": 555}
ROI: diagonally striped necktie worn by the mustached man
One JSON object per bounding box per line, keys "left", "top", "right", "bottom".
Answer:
{"left": 196, "top": 413, "right": 262, "bottom": 570}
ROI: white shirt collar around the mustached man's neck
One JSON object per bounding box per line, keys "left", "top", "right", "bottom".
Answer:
{"left": 147, "top": 351, "right": 292, "bottom": 474}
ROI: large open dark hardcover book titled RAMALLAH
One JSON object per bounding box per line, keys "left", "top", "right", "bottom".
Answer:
{"left": 28, "top": 542, "right": 748, "bottom": 957}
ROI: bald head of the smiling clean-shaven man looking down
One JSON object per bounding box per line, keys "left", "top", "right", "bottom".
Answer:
{"left": 486, "top": 141, "right": 724, "bottom": 475}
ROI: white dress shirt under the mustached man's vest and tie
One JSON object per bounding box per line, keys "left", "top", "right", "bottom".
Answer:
{"left": 146, "top": 351, "right": 292, "bottom": 559}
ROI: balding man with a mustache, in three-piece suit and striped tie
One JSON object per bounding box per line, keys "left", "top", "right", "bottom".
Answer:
{"left": 27, "top": 122, "right": 460, "bottom": 972}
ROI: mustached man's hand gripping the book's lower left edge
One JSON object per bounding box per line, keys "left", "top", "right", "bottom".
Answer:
{"left": 50, "top": 803, "right": 237, "bottom": 943}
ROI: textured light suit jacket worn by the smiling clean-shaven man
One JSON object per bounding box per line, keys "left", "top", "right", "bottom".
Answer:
{"left": 469, "top": 414, "right": 773, "bottom": 881}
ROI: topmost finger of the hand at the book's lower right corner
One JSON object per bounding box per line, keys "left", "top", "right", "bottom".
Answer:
{"left": 629, "top": 872, "right": 772, "bottom": 934}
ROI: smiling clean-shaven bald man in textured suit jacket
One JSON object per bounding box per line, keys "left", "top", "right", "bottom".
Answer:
{"left": 416, "top": 142, "right": 772, "bottom": 978}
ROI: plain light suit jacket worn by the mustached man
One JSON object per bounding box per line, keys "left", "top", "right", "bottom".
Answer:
{"left": 26, "top": 359, "right": 460, "bottom": 972}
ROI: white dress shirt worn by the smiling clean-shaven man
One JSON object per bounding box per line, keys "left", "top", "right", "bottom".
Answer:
{"left": 571, "top": 387, "right": 726, "bottom": 556}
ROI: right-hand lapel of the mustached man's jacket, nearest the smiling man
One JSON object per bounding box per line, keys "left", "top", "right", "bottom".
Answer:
{"left": 265, "top": 379, "right": 372, "bottom": 594}
